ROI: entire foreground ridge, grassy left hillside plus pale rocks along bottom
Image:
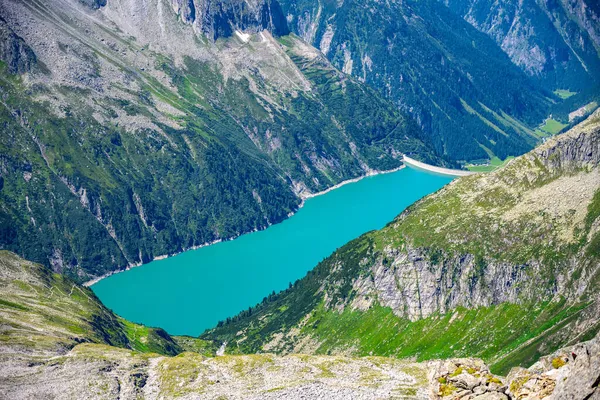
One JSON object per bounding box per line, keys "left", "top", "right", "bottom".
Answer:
{"left": 0, "top": 251, "right": 600, "bottom": 400}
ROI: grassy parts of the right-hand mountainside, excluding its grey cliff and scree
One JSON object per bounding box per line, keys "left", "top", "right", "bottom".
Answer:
{"left": 202, "top": 113, "right": 600, "bottom": 372}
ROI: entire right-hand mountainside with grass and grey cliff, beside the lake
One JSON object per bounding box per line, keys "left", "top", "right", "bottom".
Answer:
{"left": 202, "top": 111, "right": 600, "bottom": 372}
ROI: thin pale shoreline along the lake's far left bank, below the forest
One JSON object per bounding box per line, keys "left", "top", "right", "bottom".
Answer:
{"left": 82, "top": 164, "right": 406, "bottom": 287}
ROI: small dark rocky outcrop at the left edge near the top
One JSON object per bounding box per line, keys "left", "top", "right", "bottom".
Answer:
{"left": 0, "top": 17, "right": 37, "bottom": 74}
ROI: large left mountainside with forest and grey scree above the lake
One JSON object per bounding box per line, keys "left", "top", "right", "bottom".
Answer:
{"left": 0, "top": 0, "right": 443, "bottom": 281}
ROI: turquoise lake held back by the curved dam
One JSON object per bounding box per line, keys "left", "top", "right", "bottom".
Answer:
{"left": 92, "top": 168, "right": 452, "bottom": 336}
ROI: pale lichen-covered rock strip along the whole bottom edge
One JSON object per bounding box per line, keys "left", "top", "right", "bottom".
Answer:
{"left": 0, "top": 338, "right": 600, "bottom": 400}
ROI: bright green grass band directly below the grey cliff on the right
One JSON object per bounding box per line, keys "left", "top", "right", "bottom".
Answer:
{"left": 292, "top": 299, "right": 586, "bottom": 374}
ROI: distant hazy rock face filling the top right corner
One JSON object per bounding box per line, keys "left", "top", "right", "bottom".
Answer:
{"left": 444, "top": 0, "right": 600, "bottom": 91}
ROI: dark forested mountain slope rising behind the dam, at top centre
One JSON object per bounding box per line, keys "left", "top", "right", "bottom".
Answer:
{"left": 282, "top": 0, "right": 558, "bottom": 160}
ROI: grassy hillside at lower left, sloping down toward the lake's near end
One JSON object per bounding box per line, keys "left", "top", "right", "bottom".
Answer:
{"left": 0, "top": 251, "right": 215, "bottom": 355}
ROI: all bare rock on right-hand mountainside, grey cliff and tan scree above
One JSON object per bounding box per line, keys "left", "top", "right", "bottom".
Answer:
{"left": 344, "top": 111, "right": 600, "bottom": 321}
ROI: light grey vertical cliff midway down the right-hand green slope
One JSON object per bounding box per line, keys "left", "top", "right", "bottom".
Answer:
{"left": 351, "top": 244, "right": 566, "bottom": 321}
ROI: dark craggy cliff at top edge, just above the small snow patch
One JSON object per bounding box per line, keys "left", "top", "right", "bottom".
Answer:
{"left": 172, "top": 0, "right": 289, "bottom": 40}
